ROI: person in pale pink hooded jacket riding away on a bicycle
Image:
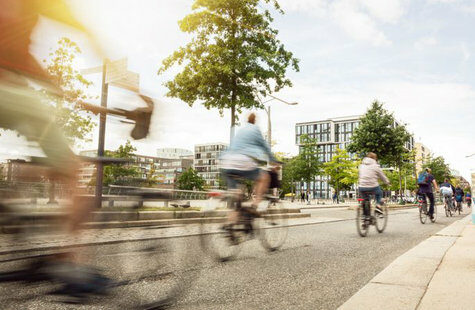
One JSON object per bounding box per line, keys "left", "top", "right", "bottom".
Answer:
{"left": 358, "top": 152, "right": 389, "bottom": 216}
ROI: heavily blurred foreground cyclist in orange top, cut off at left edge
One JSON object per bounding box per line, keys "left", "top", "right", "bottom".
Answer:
{"left": 0, "top": 0, "right": 108, "bottom": 294}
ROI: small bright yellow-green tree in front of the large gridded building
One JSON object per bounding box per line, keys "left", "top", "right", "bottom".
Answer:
{"left": 323, "top": 147, "right": 358, "bottom": 199}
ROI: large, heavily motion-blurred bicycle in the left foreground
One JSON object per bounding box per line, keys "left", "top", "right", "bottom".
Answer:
{"left": 0, "top": 158, "right": 197, "bottom": 309}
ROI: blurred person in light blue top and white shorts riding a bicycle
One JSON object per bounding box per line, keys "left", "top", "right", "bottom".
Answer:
{"left": 220, "top": 113, "right": 277, "bottom": 221}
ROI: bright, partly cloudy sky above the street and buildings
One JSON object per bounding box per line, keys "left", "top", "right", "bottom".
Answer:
{"left": 0, "top": 0, "right": 475, "bottom": 179}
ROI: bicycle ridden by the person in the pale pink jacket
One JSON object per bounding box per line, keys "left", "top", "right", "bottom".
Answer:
{"left": 356, "top": 193, "right": 388, "bottom": 237}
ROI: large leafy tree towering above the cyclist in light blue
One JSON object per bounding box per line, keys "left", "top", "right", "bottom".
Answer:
{"left": 158, "top": 0, "right": 299, "bottom": 137}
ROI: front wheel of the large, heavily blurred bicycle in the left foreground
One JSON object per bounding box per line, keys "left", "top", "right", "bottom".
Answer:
{"left": 79, "top": 227, "right": 201, "bottom": 309}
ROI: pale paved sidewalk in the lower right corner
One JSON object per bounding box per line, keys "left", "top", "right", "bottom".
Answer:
{"left": 339, "top": 215, "right": 475, "bottom": 310}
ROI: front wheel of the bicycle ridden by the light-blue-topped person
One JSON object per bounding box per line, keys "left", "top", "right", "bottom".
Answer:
{"left": 255, "top": 199, "right": 288, "bottom": 252}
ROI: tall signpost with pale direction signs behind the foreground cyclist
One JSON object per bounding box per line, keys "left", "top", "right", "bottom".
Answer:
{"left": 81, "top": 58, "right": 140, "bottom": 208}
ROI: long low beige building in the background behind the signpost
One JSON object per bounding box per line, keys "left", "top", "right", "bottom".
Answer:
{"left": 79, "top": 150, "right": 193, "bottom": 188}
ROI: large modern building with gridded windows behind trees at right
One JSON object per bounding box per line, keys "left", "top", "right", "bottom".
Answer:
{"left": 295, "top": 115, "right": 414, "bottom": 199}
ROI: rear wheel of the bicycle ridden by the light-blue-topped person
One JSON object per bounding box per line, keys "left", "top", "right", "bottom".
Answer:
{"left": 200, "top": 198, "right": 244, "bottom": 262}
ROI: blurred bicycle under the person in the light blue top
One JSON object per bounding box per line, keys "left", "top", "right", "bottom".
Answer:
{"left": 200, "top": 173, "right": 288, "bottom": 262}
